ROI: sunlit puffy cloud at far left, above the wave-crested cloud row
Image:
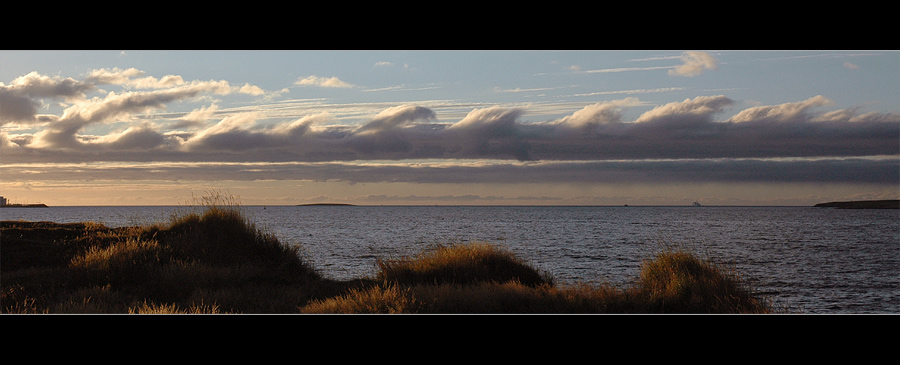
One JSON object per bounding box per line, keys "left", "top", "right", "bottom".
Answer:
{"left": 0, "top": 69, "right": 270, "bottom": 150}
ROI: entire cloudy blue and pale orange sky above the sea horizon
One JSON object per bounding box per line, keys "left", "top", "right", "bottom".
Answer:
{"left": 0, "top": 50, "right": 900, "bottom": 206}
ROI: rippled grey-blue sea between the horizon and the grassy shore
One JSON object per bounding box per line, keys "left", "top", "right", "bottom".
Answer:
{"left": 0, "top": 206, "right": 900, "bottom": 314}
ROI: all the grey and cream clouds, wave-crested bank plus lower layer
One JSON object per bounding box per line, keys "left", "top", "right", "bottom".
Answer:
{"left": 0, "top": 69, "right": 900, "bottom": 188}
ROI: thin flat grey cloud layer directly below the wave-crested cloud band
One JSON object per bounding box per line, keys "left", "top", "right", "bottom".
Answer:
{"left": 0, "top": 156, "right": 900, "bottom": 185}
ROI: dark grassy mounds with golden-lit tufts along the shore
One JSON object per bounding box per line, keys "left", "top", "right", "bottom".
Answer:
{"left": 0, "top": 205, "right": 774, "bottom": 314}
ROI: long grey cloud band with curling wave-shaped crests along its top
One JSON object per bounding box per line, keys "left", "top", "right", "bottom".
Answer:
{"left": 4, "top": 91, "right": 900, "bottom": 162}
